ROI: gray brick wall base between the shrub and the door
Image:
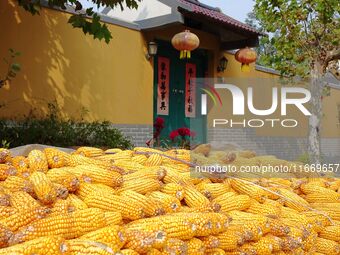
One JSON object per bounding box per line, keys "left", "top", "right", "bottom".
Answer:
{"left": 112, "top": 124, "right": 153, "bottom": 146}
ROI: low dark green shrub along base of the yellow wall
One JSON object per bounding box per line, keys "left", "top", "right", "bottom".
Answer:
{"left": 0, "top": 104, "right": 133, "bottom": 149}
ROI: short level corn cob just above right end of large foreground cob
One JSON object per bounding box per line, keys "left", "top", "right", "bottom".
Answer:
{"left": 212, "top": 193, "right": 250, "bottom": 212}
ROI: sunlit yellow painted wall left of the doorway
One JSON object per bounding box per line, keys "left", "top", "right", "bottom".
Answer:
{"left": 0, "top": 0, "right": 153, "bottom": 124}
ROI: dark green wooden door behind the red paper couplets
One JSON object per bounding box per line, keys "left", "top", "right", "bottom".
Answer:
{"left": 154, "top": 41, "right": 208, "bottom": 146}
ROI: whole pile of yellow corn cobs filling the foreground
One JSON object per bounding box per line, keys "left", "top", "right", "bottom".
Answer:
{"left": 0, "top": 146, "right": 340, "bottom": 255}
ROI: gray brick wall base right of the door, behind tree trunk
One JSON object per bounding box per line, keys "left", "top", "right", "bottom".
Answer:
{"left": 208, "top": 128, "right": 340, "bottom": 162}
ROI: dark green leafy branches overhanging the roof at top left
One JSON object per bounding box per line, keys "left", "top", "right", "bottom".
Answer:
{"left": 17, "top": 0, "right": 141, "bottom": 43}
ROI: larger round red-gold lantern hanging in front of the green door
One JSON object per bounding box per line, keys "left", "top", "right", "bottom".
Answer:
{"left": 171, "top": 30, "right": 200, "bottom": 59}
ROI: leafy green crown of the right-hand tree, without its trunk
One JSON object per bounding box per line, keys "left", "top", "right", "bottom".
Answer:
{"left": 255, "top": 0, "right": 340, "bottom": 76}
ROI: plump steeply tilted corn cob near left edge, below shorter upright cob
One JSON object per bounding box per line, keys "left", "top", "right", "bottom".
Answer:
{"left": 29, "top": 172, "right": 57, "bottom": 204}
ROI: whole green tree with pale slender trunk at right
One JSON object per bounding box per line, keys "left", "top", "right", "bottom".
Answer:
{"left": 254, "top": 0, "right": 340, "bottom": 163}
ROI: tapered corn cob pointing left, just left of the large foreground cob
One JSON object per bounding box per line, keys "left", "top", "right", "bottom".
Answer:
{"left": 79, "top": 225, "right": 126, "bottom": 249}
